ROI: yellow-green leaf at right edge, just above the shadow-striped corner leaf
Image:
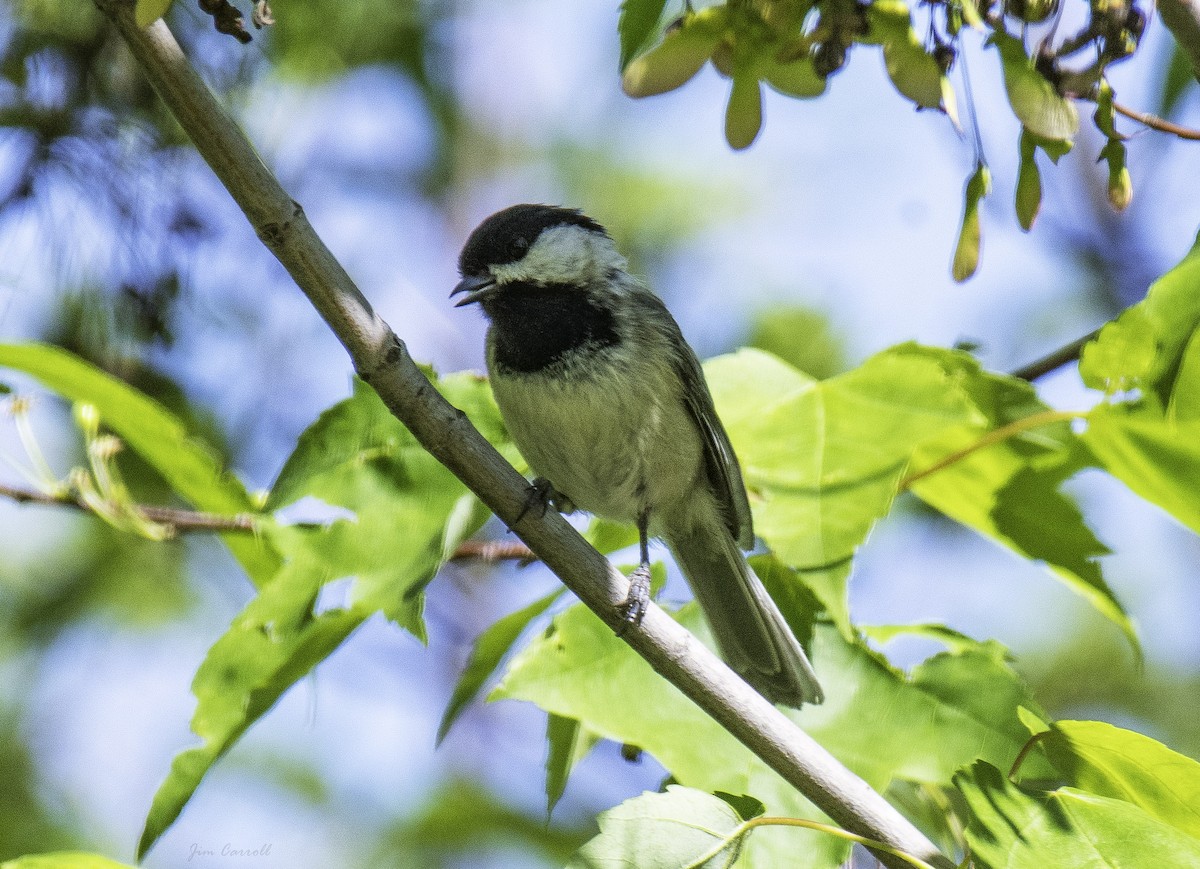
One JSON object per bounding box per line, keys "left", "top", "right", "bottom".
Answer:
{"left": 1040, "top": 721, "right": 1200, "bottom": 838}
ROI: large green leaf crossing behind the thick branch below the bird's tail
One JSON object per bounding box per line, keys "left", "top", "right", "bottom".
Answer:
{"left": 492, "top": 606, "right": 1044, "bottom": 867}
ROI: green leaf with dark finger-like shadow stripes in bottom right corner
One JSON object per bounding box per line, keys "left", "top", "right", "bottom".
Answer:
{"left": 954, "top": 761, "right": 1200, "bottom": 869}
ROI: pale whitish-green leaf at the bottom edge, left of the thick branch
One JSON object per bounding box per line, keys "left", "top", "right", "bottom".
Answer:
{"left": 568, "top": 785, "right": 742, "bottom": 869}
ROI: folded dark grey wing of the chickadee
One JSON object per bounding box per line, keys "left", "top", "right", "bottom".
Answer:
{"left": 646, "top": 294, "right": 754, "bottom": 550}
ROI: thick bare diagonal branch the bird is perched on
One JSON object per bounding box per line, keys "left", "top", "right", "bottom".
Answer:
{"left": 97, "top": 0, "right": 954, "bottom": 869}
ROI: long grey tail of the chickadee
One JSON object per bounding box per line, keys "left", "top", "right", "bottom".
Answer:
{"left": 664, "top": 508, "right": 824, "bottom": 707}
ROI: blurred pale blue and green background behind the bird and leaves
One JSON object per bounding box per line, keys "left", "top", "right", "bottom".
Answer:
{"left": 0, "top": 0, "right": 1200, "bottom": 869}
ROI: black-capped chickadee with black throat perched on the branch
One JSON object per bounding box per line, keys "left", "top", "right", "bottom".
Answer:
{"left": 451, "top": 205, "right": 823, "bottom": 706}
